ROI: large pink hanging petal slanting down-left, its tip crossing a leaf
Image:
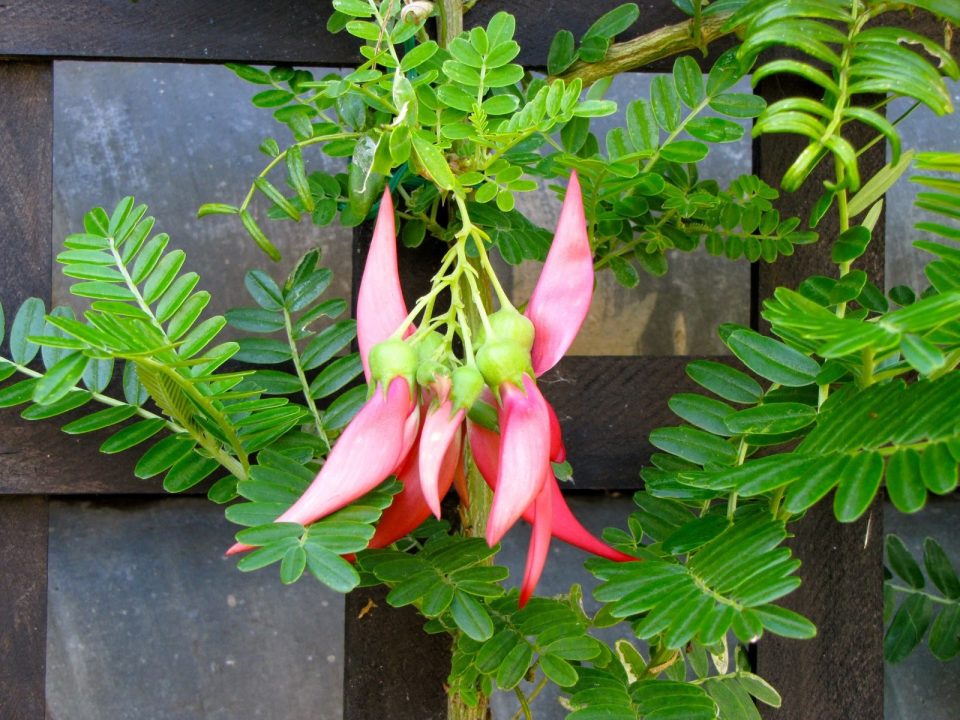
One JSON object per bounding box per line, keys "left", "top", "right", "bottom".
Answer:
{"left": 227, "top": 377, "right": 419, "bottom": 555}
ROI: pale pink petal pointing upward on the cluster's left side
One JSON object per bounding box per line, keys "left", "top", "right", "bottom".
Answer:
{"left": 357, "top": 191, "right": 407, "bottom": 382}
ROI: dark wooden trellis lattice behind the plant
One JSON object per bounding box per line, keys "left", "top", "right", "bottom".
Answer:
{"left": 0, "top": 0, "right": 944, "bottom": 720}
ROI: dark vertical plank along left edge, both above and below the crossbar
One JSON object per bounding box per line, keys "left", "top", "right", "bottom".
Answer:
{"left": 0, "top": 57, "right": 53, "bottom": 720}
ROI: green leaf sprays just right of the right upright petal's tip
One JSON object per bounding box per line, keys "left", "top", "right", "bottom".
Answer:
{"left": 530, "top": 51, "right": 817, "bottom": 287}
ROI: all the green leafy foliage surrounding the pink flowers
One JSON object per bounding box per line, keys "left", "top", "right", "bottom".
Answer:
{"left": 0, "top": 0, "right": 960, "bottom": 720}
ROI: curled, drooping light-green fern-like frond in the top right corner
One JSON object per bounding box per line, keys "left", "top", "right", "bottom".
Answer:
{"left": 729, "top": 0, "right": 960, "bottom": 191}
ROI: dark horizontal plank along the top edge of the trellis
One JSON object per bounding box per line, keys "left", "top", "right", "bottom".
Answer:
{"left": 0, "top": 0, "right": 712, "bottom": 67}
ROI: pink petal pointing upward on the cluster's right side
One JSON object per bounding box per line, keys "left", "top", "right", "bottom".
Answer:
{"left": 525, "top": 173, "right": 593, "bottom": 376}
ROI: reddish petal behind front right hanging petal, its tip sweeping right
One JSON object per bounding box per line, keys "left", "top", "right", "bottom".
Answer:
{"left": 467, "top": 421, "right": 636, "bottom": 561}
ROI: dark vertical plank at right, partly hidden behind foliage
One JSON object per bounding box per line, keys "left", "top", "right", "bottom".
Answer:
{"left": 754, "top": 78, "right": 885, "bottom": 720}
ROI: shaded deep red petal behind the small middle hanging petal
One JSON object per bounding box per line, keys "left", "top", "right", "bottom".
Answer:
{"left": 368, "top": 416, "right": 461, "bottom": 548}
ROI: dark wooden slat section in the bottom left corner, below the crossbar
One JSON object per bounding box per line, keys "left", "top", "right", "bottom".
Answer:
{"left": 0, "top": 497, "right": 49, "bottom": 720}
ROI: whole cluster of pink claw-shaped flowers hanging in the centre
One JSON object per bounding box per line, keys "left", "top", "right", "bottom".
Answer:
{"left": 228, "top": 174, "right": 634, "bottom": 605}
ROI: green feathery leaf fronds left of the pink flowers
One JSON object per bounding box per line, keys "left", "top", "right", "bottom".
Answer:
{"left": 0, "top": 198, "right": 390, "bottom": 591}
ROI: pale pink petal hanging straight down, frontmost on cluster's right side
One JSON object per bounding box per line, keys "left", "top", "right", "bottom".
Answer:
{"left": 486, "top": 375, "right": 550, "bottom": 546}
